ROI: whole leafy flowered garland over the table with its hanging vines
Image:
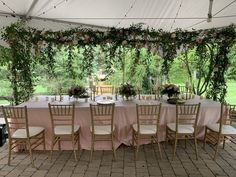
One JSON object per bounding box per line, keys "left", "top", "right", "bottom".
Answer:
{"left": 2, "top": 21, "right": 236, "bottom": 104}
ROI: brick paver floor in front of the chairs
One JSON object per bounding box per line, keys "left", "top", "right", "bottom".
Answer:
{"left": 0, "top": 142, "right": 236, "bottom": 177}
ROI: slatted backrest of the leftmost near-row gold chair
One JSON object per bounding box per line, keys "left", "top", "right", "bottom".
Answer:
{"left": 2, "top": 106, "right": 29, "bottom": 138}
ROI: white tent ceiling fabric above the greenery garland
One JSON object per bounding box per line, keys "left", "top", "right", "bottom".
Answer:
{"left": 0, "top": 0, "right": 236, "bottom": 31}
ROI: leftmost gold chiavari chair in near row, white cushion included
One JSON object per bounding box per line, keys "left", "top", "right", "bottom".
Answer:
{"left": 2, "top": 106, "right": 45, "bottom": 167}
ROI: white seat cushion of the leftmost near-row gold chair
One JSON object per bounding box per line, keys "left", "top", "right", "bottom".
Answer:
{"left": 12, "top": 127, "right": 44, "bottom": 139}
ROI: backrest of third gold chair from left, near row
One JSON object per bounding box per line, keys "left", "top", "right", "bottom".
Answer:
{"left": 90, "top": 103, "right": 115, "bottom": 132}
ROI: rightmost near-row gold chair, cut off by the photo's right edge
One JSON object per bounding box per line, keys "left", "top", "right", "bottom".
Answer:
{"left": 203, "top": 103, "right": 236, "bottom": 160}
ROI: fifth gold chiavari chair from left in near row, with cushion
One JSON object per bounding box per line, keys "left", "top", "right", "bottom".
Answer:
{"left": 166, "top": 103, "right": 200, "bottom": 159}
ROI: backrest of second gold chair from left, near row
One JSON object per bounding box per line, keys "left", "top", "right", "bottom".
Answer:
{"left": 48, "top": 103, "right": 75, "bottom": 133}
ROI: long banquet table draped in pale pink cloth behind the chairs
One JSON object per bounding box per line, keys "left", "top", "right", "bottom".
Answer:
{"left": 19, "top": 96, "right": 220, "bottom": 150}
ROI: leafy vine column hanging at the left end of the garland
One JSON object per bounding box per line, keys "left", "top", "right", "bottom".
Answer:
{"left": 2, "top": 23, "right": 34, "bottom": 104}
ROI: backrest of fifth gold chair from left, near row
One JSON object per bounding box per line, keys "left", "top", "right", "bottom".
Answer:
{"left": 176, "top": 103, "right": 201, "bottom": 132}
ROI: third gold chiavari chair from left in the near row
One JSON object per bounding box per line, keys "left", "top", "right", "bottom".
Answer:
{"left": 90, "top": 103, "right": 116, "bottom": 161}
